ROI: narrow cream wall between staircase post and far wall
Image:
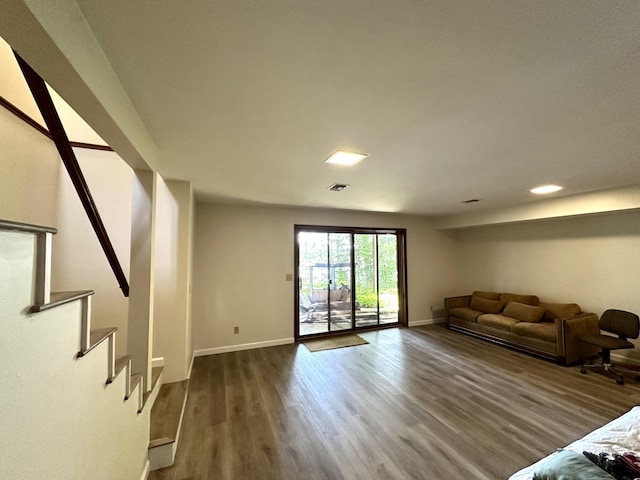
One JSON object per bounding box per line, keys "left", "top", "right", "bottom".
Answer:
{"left": 153, "top": 178, "right": 193, "bottom": 383}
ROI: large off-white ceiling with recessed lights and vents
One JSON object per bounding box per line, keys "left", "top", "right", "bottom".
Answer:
{"left": 0, "top": 0, "right": 640, "bottom": 215}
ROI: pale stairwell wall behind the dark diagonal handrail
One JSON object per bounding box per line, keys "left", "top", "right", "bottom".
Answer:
{"left": 52, "top": 148, "right": 133, "bottom": 355}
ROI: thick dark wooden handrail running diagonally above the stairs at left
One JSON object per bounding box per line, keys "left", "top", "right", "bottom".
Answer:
{"left": 13, "top": 51, "right": 129, "bottom": 297}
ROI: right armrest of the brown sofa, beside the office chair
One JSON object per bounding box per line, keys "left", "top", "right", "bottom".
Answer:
{"left": 555, "top": 313, "right": 600, "bottom": 365}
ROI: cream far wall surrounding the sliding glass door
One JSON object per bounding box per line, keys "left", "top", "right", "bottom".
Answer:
{"left": 193, "top": 203, "right": 456, "bottom": 351}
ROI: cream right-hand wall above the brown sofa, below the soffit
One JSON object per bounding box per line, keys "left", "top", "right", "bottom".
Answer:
{"left": 449, "top": 212, "right": 640, "bottom": 356}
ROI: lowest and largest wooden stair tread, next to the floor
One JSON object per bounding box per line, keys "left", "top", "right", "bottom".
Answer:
{"left": 149, "top": 379, "right": 189, "bottom": 448}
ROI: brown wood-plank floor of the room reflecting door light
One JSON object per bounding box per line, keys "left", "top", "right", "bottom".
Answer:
{"left": 149, "top": 326, "right": 640, "bottom": 480}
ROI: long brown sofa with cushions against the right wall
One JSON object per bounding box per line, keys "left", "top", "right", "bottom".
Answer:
{"left": 444, "top": 291, "right": 600, "bottom": 365}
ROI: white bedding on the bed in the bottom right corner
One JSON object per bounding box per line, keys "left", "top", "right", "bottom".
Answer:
{"left": 509, "top": 406, "right": 640, "bottom": 480}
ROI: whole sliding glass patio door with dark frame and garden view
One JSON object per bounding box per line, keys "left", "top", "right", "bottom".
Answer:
{"left": 295, "top": 225, "right": 407, "bottom": 339}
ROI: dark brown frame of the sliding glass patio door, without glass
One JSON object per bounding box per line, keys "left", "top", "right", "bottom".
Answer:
{"left": 293, "top": 224, "right": 409, "bottom": 341}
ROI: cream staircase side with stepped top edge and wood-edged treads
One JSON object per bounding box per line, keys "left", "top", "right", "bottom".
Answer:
{"left": 0, "top": 220, "right": 161, "bottom": 480}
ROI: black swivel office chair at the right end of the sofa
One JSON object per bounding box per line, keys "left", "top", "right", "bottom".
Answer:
{"left": 577, "top": 309, "right": 640, "bottom": 385}
